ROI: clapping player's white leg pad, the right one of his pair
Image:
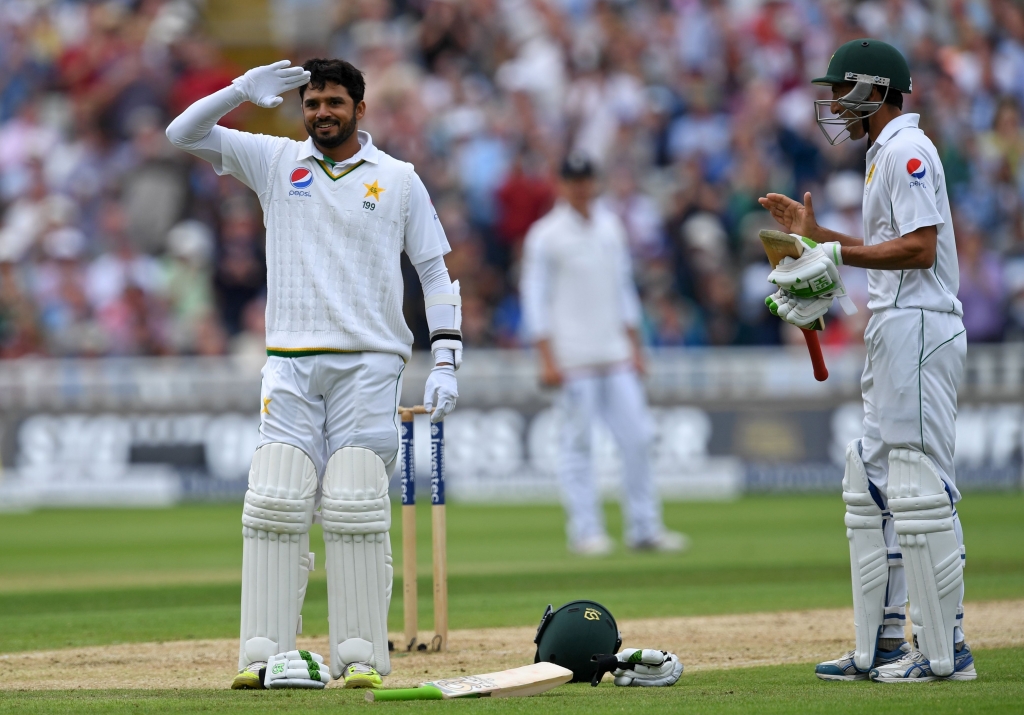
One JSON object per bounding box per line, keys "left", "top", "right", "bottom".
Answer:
{"left": 889, "top": 450, "right": 964, "bottom": 676}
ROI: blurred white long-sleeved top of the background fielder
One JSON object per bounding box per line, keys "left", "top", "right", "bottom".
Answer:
{"left": 519, "top": 202, "right": 640, "bottom": 370}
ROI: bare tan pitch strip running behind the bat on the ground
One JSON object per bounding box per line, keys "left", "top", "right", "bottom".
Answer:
{"left": 0, "top": 600, "right": 1024, "bottom": 689}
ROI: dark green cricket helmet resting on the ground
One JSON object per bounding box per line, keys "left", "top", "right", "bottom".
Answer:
{"left": 534, "top": 600, "right": 623, "bottom": 682}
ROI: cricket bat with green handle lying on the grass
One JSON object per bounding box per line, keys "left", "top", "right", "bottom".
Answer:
{"left": 367, "top": 663, "right": 572, "bottom": 703}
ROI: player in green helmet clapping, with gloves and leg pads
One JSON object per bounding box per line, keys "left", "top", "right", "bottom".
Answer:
{"left": 760, "top": 39, "right": 977, "bottom": 682}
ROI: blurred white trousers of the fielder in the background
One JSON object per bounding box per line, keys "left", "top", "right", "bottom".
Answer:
{"left": 558, "top": 367, "right": 664, "bottom": 544}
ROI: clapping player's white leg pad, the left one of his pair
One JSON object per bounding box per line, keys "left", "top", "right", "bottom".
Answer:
{"left": 843, "top": 439, "right": 889, "bottom": 671}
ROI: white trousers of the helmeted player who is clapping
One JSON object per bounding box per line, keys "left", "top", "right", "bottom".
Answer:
{"left": 860, "top": 308, "right": 967, "bottom": 640}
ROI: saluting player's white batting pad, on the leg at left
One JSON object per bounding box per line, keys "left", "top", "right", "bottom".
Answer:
{"left": 239, "top": 443, "right": 316, "bottom": 669}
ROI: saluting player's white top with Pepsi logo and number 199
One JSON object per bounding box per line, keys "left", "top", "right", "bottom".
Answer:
{"left": 214, "top": 127, "right": 452, "bottom": 361}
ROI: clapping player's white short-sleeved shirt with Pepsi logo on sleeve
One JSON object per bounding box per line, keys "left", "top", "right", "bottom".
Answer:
{"left": 864, "top": 114, "right": 964, "bottom": 317}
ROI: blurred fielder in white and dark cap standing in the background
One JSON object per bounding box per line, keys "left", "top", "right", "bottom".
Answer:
{"left": 520, "top": 154, "right": 687, "bottom": 556}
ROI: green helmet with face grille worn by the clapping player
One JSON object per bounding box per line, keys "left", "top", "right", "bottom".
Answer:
{"left": 811, "top": 38, "right": 913, "bottom": 145}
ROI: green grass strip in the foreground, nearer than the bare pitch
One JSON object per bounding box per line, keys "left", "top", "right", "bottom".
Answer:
{"left": 0, "top": 648, "right": 1024, "bottom": 715}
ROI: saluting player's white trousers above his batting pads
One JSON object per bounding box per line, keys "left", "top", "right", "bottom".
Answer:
{"left": 259, "top": 352, "right": 406, "bottom": 478}
